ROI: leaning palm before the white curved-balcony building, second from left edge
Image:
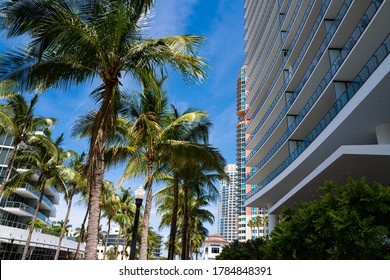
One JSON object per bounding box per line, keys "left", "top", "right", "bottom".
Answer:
{"left": 7, "top": 135, "right": 63, "bottom": 260}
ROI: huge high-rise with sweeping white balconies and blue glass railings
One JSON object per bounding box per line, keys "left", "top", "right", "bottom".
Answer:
{"left": 244, "top": 0, "right": 390, "bottom": 232}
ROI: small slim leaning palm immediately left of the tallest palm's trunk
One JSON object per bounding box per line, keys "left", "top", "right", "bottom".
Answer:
{"left": 54, "top": 151, "right": 87, "bottom": 260}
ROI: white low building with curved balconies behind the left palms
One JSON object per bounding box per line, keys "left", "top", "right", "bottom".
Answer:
{"left": 0, "top": 135, "right": 84, "bottom": 260}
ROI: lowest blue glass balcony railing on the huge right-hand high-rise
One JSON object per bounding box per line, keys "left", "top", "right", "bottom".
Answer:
{"left": 246, "top": 32, "right": 390, "bottom": 199}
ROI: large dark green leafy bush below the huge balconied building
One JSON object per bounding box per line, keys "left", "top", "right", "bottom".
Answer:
{"left": 267, "top": 178, "right": 390, "bottom": 259}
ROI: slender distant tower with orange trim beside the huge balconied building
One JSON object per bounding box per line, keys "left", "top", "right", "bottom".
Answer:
{"left": 236, "top": 65, "right": 264, "bottom": 241}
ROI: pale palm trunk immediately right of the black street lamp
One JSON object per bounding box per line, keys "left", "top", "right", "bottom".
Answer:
{"left": 139, "top": 160, "right": 153, "bottom": 260}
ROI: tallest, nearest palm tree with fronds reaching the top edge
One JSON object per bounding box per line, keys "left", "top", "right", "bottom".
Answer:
{"left": 0, "top": 0, "right": 206, "bottom": 259}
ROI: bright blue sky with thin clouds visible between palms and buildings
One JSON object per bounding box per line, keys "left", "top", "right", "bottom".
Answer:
{"left": 0, "top": 0, "right": 244, "bottom": 241}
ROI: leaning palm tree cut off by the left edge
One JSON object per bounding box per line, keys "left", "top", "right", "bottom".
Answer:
{"left": 0, "top": 93, "right": 54, "bottom": 197}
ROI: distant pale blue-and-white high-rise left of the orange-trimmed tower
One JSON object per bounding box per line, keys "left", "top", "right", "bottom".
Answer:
{"left": 218, "top": 164, "right": 237, "bottom": 241}
